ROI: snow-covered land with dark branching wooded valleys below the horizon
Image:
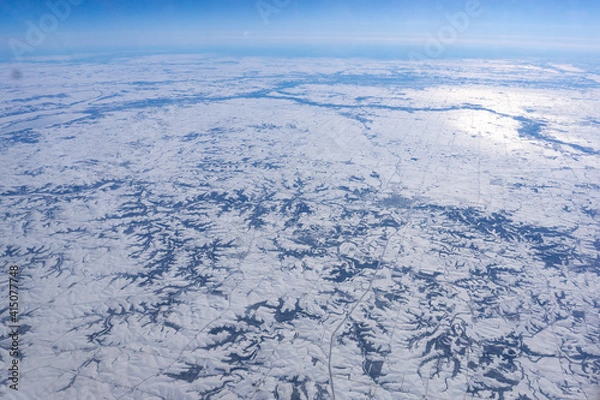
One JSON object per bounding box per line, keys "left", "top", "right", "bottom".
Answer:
{"left": 0, "top": 55, "right": 600, "bottom": 400}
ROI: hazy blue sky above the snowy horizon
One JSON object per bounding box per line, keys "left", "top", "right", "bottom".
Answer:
{"left": 0, "top": 0, "right": 600, "bottom": 58}
